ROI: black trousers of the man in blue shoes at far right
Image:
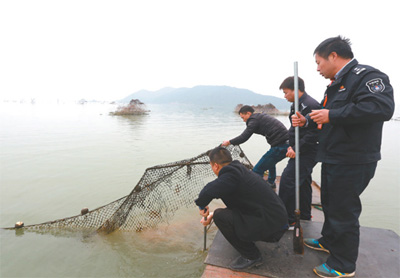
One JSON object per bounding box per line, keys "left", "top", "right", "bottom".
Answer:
{"left": 319, "top": 162, "right": 377, "bottom": 272}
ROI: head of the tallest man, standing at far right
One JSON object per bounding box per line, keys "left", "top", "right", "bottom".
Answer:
{"left": 314, "top": 36, "right": 354, "bottom": 79}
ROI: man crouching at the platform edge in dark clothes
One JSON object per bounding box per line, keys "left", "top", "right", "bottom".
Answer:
{"left": 195, "top": 147, "right": 287, "bottom": 270}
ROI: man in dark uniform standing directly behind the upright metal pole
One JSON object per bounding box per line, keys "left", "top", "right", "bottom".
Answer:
{"left": 279, "top": 76, "right": 320, "bottom": 227}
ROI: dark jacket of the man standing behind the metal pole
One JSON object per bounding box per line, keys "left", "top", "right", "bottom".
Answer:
{"left": 289, "top": 92, "right": 321, "bottom": 154}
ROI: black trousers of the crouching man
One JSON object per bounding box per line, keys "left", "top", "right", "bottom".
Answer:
{"left": 213, "top": 208, "right": 286, "bottom": 260}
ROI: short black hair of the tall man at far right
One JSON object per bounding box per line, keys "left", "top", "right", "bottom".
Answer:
{"left": 314, "top": 36, "right": 354, "bottom": 59}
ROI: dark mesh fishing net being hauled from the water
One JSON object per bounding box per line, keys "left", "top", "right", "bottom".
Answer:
{"left": 4, "top": 145, "right": 253, "bottom": 233}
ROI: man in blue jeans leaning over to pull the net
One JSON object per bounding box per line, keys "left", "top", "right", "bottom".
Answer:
{"left": 222, "top": 105, "right": 289, "bottom": 188}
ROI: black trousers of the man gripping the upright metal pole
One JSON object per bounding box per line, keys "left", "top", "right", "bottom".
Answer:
{"left": 279, "top": 152, "right": 316, "bottom": 224}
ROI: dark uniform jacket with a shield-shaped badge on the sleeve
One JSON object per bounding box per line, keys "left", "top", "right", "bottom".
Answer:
{"left": 308, "top": 59, "right": 394, "bottom": 164}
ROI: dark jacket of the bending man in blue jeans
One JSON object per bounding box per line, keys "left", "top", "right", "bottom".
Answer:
{"left": 229, "top": 113, "right": 289, "bottom": 147}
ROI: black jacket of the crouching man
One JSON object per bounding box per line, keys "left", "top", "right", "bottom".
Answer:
{"left": 195, "top": 161, "right": 287, "bottom": 241}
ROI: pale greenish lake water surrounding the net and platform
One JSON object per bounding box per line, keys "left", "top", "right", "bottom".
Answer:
{"left": 0, "top": 103, "right": 400, "bottom": 277}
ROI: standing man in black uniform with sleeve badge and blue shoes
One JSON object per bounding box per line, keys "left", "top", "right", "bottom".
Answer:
{"left": 292, "top": 36, "right": 394, "bottom": 277}
